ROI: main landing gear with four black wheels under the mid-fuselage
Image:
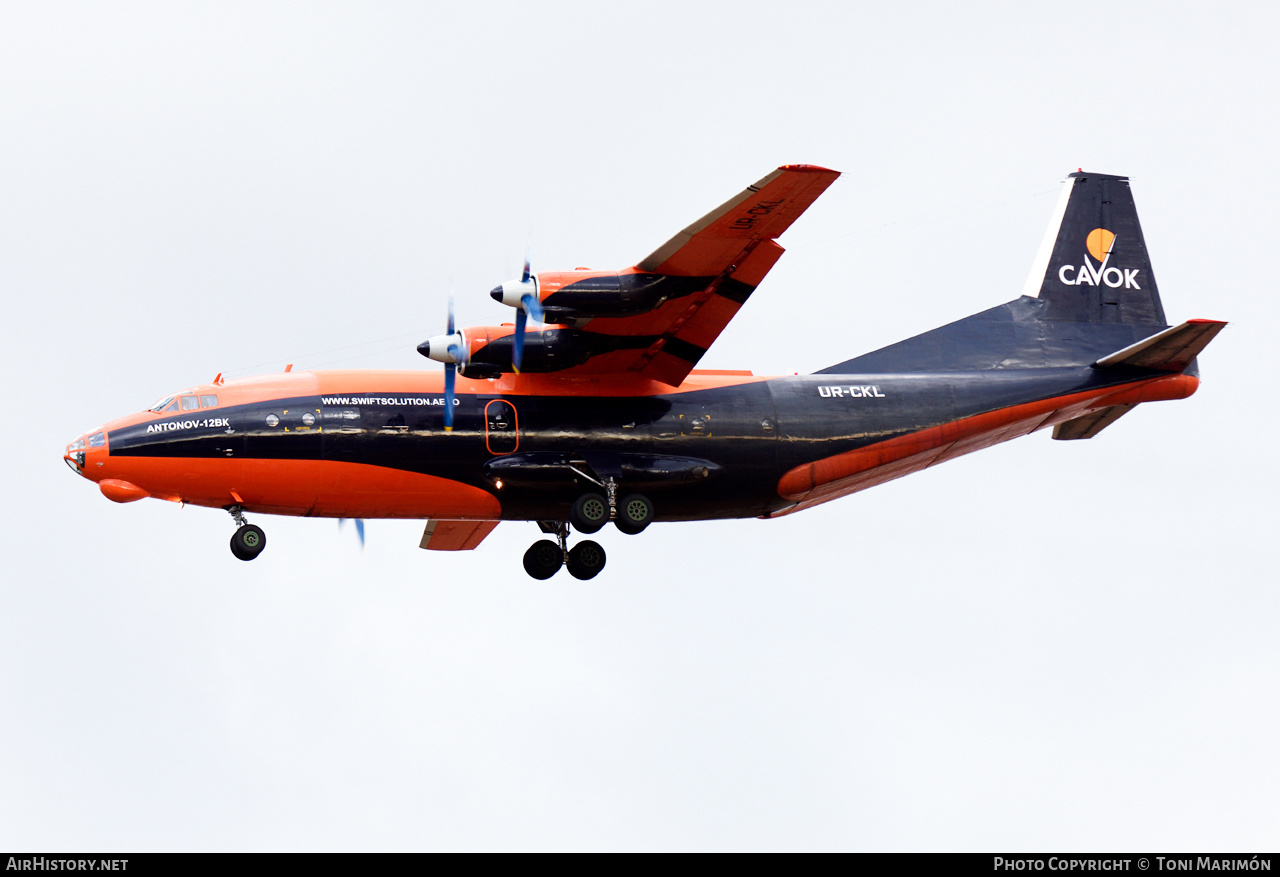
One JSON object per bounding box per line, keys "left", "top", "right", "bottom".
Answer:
{"left": 525, "top": 489, "right": 653, "bottom": 581}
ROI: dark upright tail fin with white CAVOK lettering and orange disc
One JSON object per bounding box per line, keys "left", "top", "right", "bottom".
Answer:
{"left": 1024, "top": 172, "right": 1165, "bottom": 326}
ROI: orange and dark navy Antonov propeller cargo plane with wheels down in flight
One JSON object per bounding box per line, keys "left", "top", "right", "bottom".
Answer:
{"left": 64, "top": 165, "right": 1226, "bottom": 580}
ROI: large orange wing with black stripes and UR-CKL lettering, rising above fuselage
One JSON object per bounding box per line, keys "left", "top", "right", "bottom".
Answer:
{"left": 561, "top": 164, "right": 840, "bottom": 387}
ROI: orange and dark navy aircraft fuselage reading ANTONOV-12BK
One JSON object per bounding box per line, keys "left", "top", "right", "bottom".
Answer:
{"left": 69, "top": 366, "right": 1198, "bottom": 521}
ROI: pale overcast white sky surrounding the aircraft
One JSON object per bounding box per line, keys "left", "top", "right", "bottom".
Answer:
{"left": 0, "top": 1, "right": 1280, "bottom": 851}
